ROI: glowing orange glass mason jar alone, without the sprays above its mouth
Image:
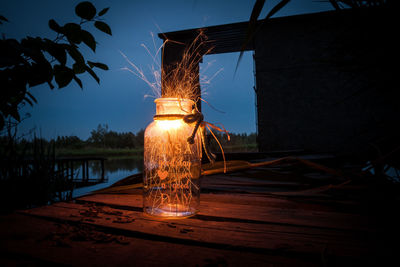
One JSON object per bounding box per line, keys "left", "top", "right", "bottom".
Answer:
{"left": 143, "top": 98, "right": 201, "bottom": 218}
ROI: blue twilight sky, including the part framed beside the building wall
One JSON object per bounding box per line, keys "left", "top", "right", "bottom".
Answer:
{"left": 0, "top": 0, "right": 332, "bottom": 139}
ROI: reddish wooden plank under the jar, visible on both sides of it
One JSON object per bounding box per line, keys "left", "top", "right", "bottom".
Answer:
{"left": 78, "top": 194, "right": 370, "bottom": 232}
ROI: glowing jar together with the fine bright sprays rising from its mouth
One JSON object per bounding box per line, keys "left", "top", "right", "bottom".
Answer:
{"left": 122, "top": 32, "right": 226, "bottom": 218}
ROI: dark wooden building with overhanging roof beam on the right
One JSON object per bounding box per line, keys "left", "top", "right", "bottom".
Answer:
{"left": 159, "top": 8, "right": 400, "bottom": 154}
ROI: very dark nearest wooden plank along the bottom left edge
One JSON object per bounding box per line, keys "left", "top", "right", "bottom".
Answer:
{"left": 0, "top": 214, "right": 322, "bottom": 266}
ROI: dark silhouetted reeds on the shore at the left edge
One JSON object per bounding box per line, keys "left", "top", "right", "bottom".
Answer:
{"left": 0, "top": 131, "right": 73, "bottom": 213}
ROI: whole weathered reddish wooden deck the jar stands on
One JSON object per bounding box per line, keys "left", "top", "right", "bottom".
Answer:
{"left": 0, "top": 160, "right": 400, "bottom": 266}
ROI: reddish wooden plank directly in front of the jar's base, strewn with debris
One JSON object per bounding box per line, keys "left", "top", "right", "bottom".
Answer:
{"left": 18, "top": 203, "right": 366, "bottom": 257}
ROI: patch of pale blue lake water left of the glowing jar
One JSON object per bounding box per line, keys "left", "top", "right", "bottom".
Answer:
{"left": 72, "top": 158, "right": 143, "bottom": 197}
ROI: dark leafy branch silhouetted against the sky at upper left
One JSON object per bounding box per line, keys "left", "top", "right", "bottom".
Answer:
{"left": 0, "top": 1, "right": 111, "bottom": 130}
